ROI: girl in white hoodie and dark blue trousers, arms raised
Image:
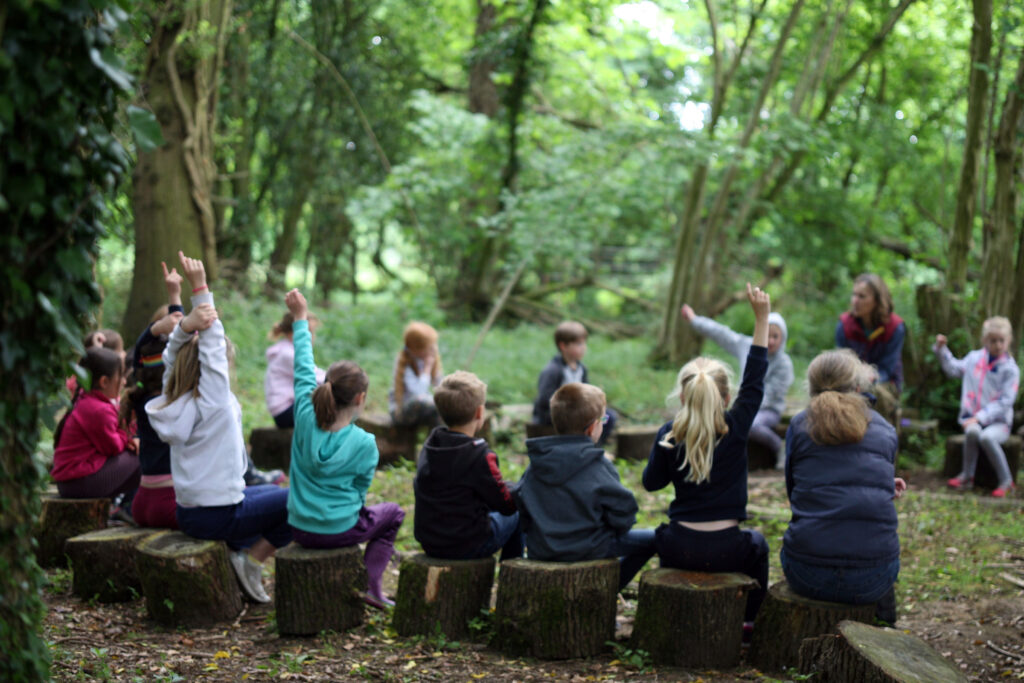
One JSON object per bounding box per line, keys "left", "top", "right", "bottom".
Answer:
{"left": 145, "top": 252, "right": 292, "bottom": 602}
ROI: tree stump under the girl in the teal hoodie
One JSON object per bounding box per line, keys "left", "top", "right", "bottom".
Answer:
{"left": 273, "top": 543, "right": 367, "bottom": 636}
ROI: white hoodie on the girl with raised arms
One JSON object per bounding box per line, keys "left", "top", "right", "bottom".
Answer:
{"left": 145, "top": 292, "right": 247, "bottom": 507}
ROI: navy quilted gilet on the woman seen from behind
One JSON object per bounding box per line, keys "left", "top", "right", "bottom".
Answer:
{"left": 782, "top": 411, "right": 899, "bottom": 567}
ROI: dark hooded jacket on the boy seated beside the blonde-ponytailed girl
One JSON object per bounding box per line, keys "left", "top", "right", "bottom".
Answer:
{"left": 513, "top": 434, "right": 637, "bottom": 562}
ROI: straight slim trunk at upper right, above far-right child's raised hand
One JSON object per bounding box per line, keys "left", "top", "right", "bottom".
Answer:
{"left": 946, "top": 0, "right": 992, "bottom": 293}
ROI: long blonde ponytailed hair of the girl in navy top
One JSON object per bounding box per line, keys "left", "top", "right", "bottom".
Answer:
{"left": 660, "top": 357, "right": 729, "bottom": 483}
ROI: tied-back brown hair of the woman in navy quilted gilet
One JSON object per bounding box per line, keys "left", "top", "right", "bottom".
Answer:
{"left": 807, "top": 348, "right": 870, "bottom": 445}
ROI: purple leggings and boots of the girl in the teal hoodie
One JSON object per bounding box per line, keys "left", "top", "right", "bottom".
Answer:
{"left": 292, "top": 503, "right": 406, "bottom": 598}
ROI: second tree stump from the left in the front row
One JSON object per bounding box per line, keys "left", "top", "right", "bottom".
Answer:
{"left": 65, "top": 526, "right": 159, "bottom": 602}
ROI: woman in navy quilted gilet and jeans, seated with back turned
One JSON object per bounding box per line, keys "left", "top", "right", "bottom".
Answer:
{"left": 779, "top": 349, "right": 906, "bottom": 624}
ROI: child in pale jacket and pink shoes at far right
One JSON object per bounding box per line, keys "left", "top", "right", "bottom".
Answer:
{"left": 933, "top": 316, "right": 1020, "bottom": 498}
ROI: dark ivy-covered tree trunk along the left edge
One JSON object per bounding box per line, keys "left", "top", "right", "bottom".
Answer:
{"left": 0, "top": 0, "right": 130, "bottom": 681}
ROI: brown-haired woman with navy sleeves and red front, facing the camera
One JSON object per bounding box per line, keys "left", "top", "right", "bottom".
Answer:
{"left": 836, "top": 272, "right": 906, "bottom": 423}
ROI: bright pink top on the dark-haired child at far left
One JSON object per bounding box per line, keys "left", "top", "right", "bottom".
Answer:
{"left": 50, "top": 390, "right": 131, "bottom": 481}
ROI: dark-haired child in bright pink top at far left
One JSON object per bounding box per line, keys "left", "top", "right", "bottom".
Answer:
{"left": 51, "top": 347, "right": 139, "bottom": 498}
